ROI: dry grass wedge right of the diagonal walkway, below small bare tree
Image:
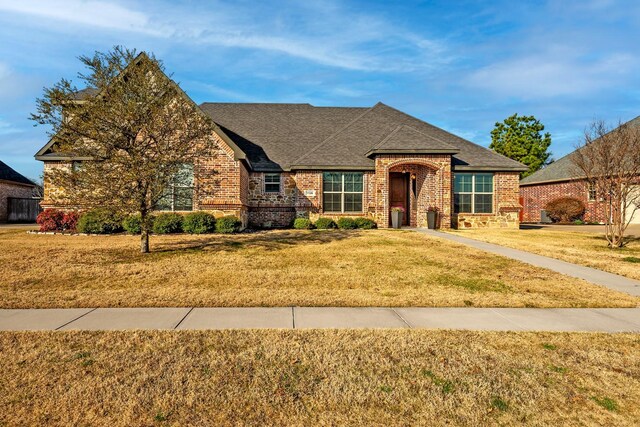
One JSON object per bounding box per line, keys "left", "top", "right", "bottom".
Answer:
{"left": 452, "top": 229, "right": 640, "bottom": 280}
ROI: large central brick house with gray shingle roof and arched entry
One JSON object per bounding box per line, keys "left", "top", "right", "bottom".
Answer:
{"left": 36, "top": 57, "right": 526, "bottom": 228}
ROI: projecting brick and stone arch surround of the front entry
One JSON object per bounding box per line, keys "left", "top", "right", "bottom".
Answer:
{"left": 375, "top": 154, "right": 452, "bottom": 228}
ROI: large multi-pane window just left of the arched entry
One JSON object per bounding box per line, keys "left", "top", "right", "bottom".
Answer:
{"left": 322, "top": 172, "right": 364, "bottom": 213}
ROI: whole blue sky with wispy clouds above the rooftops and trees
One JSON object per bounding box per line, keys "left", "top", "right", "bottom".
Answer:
{"left": 0, "top": 0, "right": 640, "bottom": 178}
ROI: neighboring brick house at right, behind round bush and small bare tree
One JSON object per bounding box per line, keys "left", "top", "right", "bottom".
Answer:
{"left": 520, "top": 117, "right": 640, "bottom": 224}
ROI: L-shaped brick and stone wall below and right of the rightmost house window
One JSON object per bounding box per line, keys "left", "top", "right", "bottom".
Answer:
{"left": 453, "top": 172, "right": 521, "bottom": 229}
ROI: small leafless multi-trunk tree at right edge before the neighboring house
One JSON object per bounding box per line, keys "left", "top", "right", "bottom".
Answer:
{"left": 572, "top": 121, "right": 640, "bottom": 248}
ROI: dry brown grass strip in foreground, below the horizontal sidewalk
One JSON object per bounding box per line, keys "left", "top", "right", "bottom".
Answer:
{"left": 0, "top": 330, "right": 640, "bottom": 426}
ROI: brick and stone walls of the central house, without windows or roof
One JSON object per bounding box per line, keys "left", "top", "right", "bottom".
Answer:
{"left": 42, "top": 130, "right": 519, "bottom": 228}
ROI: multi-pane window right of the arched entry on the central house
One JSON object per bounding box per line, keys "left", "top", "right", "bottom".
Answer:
{"left": 453, "top": 173, "right": 493, "bottom": 213}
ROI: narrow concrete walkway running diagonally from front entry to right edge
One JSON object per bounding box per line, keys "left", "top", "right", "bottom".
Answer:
{"left": 415, "top": 228, "right": 640, "bottom": 296}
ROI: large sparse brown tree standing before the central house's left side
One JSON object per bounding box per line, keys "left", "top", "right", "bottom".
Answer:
{"left": 31, "top": 46, "right": 212, "bottom": 253}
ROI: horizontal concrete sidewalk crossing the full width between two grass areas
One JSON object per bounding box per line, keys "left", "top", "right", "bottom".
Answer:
{"left": 0, "top": 307, "right": 640, "bottom": 332}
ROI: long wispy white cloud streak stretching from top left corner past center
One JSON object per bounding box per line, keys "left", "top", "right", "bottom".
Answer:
{"left": 0, "top": 0, "right": 445, "bottom": 72}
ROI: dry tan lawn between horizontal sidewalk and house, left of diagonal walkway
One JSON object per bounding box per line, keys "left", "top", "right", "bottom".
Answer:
{"left": 0, "top": 229, "right": 640, "bottom": 308}
